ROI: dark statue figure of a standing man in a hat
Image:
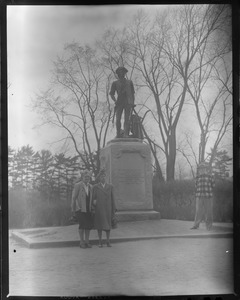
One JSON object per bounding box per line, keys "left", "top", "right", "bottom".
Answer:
{"left": 110, "top": 67, "right": 135, "bottom": 138}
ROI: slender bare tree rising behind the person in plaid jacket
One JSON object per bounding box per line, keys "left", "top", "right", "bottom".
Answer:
{"left": 187, "top": 19, "right": 232, "bottom": 164}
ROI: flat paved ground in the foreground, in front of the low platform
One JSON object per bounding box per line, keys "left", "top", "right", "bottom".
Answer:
{"left": 9, "top": 237, "right": 233, "bottom": 297}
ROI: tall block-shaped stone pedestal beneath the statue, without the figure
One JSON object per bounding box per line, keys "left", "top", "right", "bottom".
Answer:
{"left": 100, "top": 138, "right": 159, "bottom": 221}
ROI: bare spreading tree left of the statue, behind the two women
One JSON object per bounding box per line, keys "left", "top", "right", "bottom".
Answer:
{"left": 31, "top": 43, "right": 112, "bottom": 175}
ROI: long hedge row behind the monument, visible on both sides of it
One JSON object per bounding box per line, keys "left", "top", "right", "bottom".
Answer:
{"left": 9, "top": 180, "right": 233, "bottom": 228}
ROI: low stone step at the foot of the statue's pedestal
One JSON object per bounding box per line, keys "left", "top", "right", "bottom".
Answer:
{"left": 116, "top": 210, "right": 161, "bottom": 222}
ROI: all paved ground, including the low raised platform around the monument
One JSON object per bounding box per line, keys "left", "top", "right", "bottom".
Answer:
{"left": 9, "top": 220, "right": 233, "bottom": 297}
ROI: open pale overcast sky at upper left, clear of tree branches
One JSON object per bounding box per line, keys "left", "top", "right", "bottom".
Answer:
{"left": 7, "top": 5, "right": 168, "bottom": 150}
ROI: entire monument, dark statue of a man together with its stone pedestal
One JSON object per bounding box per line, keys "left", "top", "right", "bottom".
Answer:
{"left": 100, "top": 67, "right": 160, "bottom": 221}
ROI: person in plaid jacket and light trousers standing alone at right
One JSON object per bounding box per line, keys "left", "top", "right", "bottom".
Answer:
{"left": 191, "top": 163, "right": 215, "bottom": 230}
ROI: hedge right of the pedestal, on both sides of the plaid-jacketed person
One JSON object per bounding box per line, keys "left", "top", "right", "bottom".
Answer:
{"left": 153, "top": 180, "right": 233, "bottom": 222}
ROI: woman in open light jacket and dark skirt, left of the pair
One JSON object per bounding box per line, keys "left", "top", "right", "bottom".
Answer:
{"left": 71, "top": 170, "right": 93, "bottom": 248}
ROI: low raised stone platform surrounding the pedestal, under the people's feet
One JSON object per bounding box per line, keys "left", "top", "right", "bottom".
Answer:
{"left": 10, "top": 219, "right": 233, "bottom": 248}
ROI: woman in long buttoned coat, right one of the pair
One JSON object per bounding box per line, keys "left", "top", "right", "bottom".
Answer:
{"left": 92, "top": 170, "right": 116, "bottom": 247}
